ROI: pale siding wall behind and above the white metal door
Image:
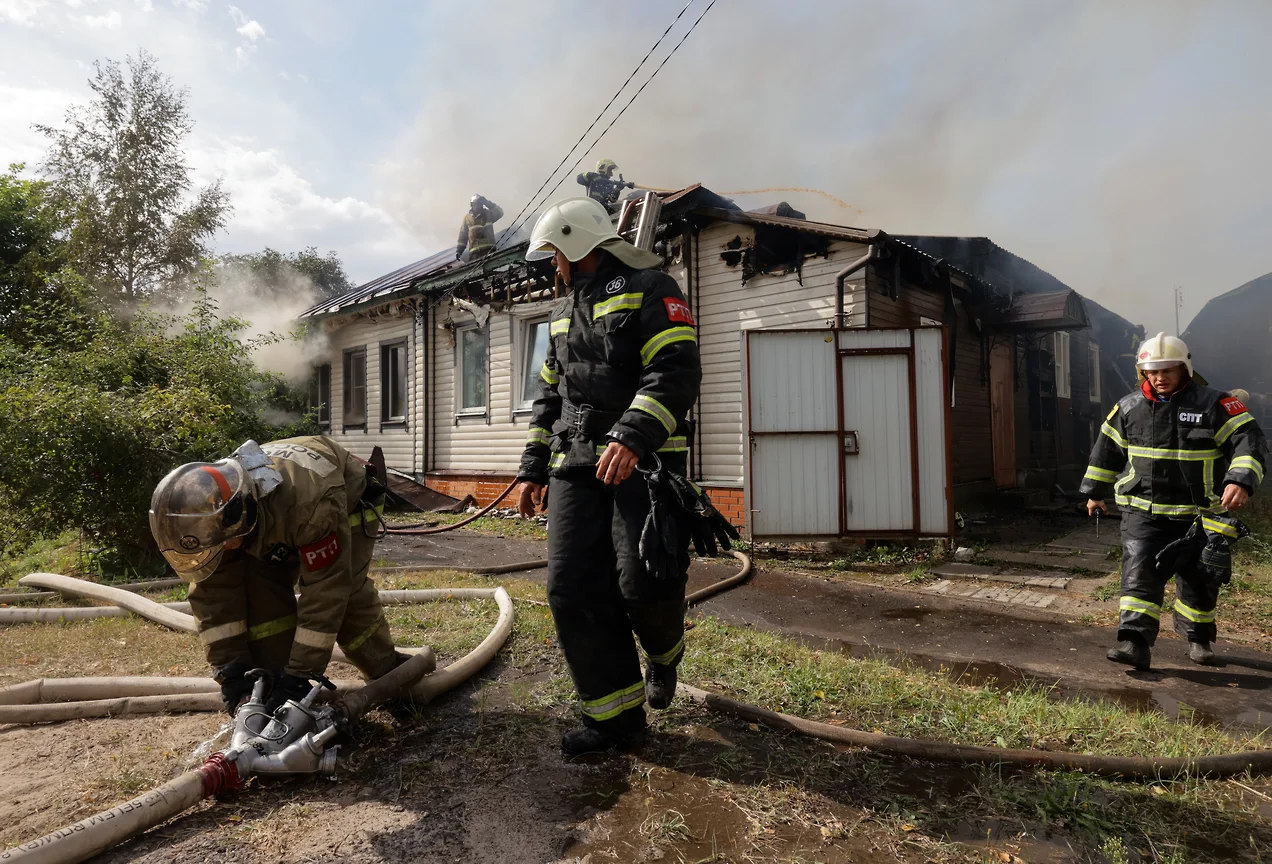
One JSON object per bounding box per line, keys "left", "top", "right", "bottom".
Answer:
{"left": 695, "top": 223, "right": 866, "bottom": 485}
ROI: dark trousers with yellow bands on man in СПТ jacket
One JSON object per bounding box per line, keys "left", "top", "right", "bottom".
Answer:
{"left": 1118, "top": 509, "right": 1219, "bottom": 645}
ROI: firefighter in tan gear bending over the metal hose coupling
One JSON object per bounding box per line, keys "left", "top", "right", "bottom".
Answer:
{"left": 150, "top": 435, "right": 406, "bottom": 715}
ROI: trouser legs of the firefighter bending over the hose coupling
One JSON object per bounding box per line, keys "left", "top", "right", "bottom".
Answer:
{"left": 234, "top": 528, "right": 397, "bottom": 678}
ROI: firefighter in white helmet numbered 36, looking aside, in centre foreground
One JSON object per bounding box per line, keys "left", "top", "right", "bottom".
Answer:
{"left": 518, "top": 199, "right": 701, "bottom": 756}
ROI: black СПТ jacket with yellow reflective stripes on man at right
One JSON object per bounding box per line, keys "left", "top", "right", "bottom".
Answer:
{"left": 1080, "top": 382, "right": 1267, "bottom": 518}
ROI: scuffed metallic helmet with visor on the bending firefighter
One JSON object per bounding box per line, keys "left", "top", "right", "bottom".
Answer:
{"left": 150, "top": 459, "right": 257, "bottom": 582}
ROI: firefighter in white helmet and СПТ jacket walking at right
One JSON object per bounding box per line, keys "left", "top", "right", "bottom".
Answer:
{"left": 1081, "top": 333, "right": 1267, "bottom": 669}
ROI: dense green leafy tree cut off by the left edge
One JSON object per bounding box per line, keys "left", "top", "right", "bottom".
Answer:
{"left": 0, "top": 164, "right": 65, "bottom": 340}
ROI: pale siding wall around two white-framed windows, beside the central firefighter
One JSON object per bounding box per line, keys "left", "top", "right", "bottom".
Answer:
{"left": 429, "top": 302, "right": 552, "bottom": 473}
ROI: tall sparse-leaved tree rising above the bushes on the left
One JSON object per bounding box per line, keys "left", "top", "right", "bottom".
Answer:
{"left": 37, "top": 51, "right": 230, "bottom": 300}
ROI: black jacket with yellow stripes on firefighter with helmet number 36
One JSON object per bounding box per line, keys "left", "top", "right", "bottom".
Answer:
{"left": 518, "top": 252, "right": 702, "bottom": 484}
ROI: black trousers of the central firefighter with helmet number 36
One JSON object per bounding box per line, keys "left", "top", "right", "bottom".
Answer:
{"left": 548, "top": 468, "right": 689, "bottom": 734}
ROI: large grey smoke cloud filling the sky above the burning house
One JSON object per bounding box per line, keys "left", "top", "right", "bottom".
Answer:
{"left": 379, "top": 0, "right": 1272, "bottom": 332}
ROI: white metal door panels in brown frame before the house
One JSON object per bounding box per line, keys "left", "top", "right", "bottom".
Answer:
{"left": 743, "top": 327, "right": 951, "bottom": 540}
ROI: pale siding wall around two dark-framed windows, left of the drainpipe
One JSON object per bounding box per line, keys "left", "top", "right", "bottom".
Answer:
{"left": 327, "top": 312, "right": 424, "bottom": 473}
